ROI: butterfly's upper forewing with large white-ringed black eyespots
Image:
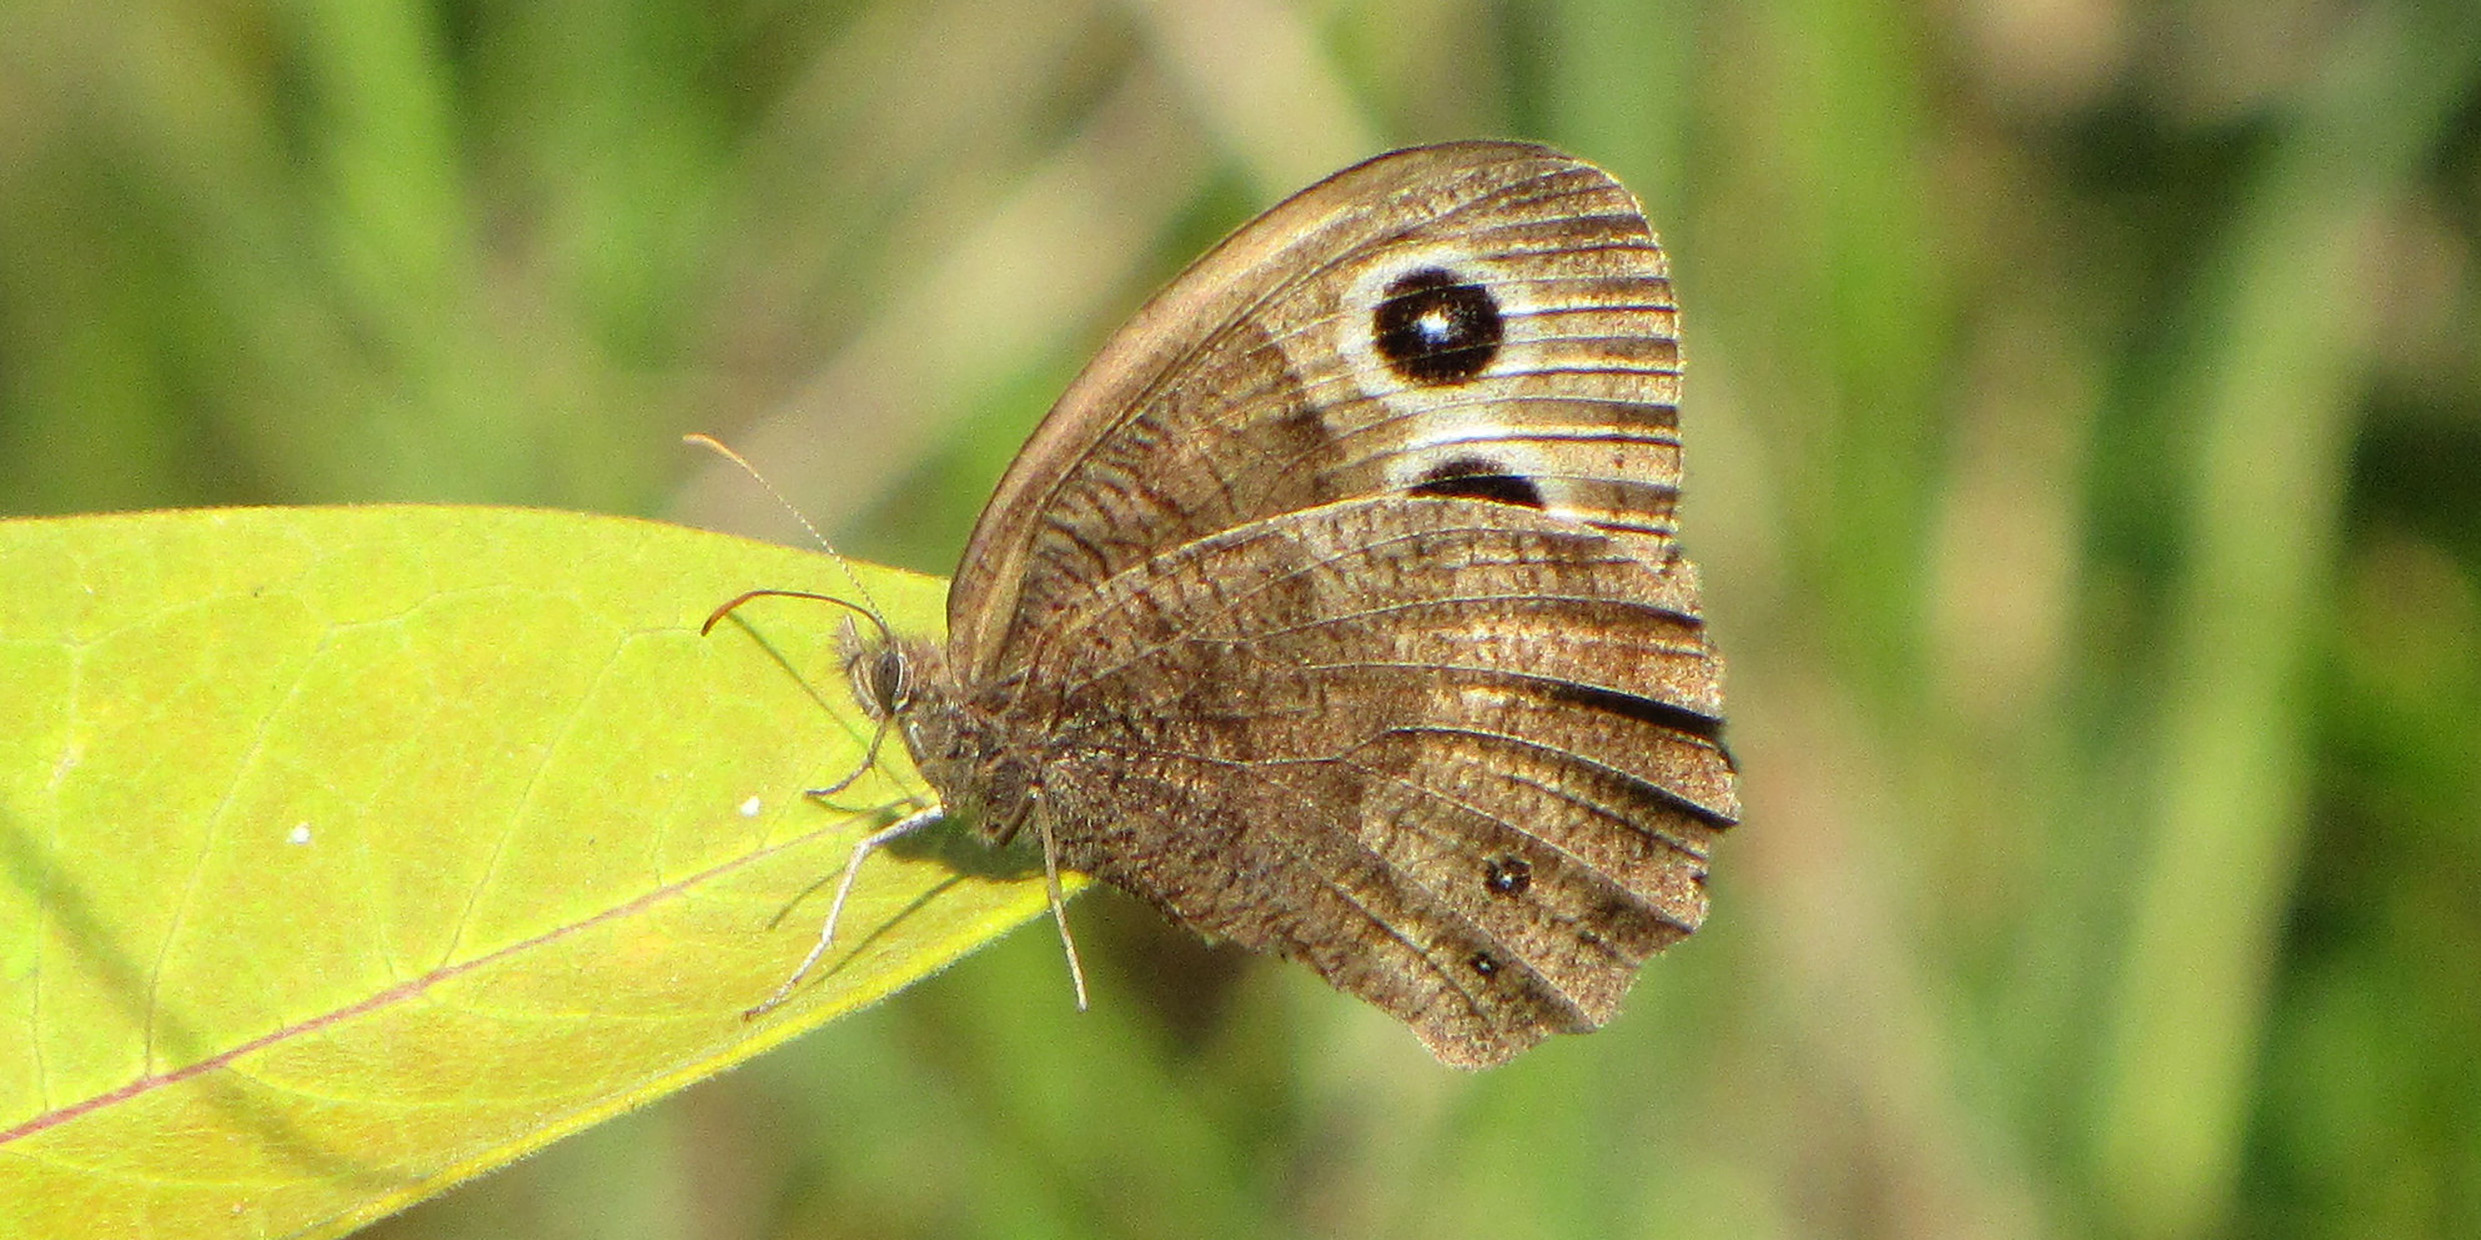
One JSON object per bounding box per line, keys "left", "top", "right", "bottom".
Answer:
{"left": 948, "top": 141, "right": 1680, "bottom": 675}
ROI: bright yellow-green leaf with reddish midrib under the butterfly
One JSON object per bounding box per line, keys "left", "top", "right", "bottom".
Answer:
{"left": 0, "top": 508, "right": 1042, "bottom": 1235}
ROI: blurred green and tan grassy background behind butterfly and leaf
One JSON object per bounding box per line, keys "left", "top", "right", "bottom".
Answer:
{"left": 0, "top": 0, "right": 2481, "bottom": 1240}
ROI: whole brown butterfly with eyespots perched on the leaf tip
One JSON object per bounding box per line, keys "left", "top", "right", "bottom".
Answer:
{"left": 717, "top": 141, "right": 1739, "bottom": 1066}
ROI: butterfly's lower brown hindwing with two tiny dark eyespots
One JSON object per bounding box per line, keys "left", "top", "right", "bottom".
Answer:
{"left": 1012, "top": 501, "right": 1737, "bottom": 1064}
